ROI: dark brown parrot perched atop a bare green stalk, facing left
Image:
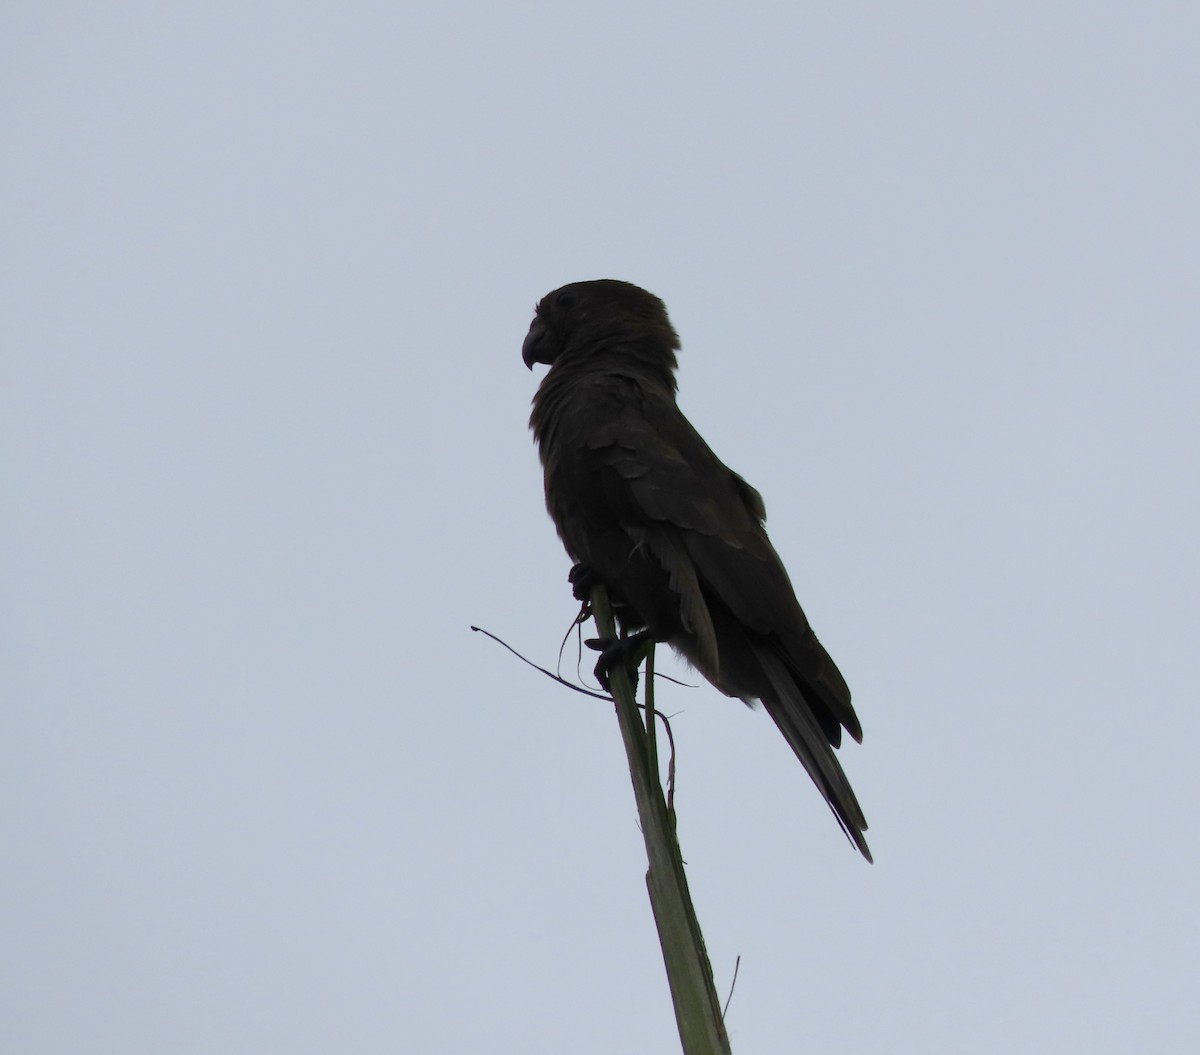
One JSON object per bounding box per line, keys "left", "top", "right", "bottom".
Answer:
{"left": 522, "top": 278, "right": 871, "bottom": 861}
